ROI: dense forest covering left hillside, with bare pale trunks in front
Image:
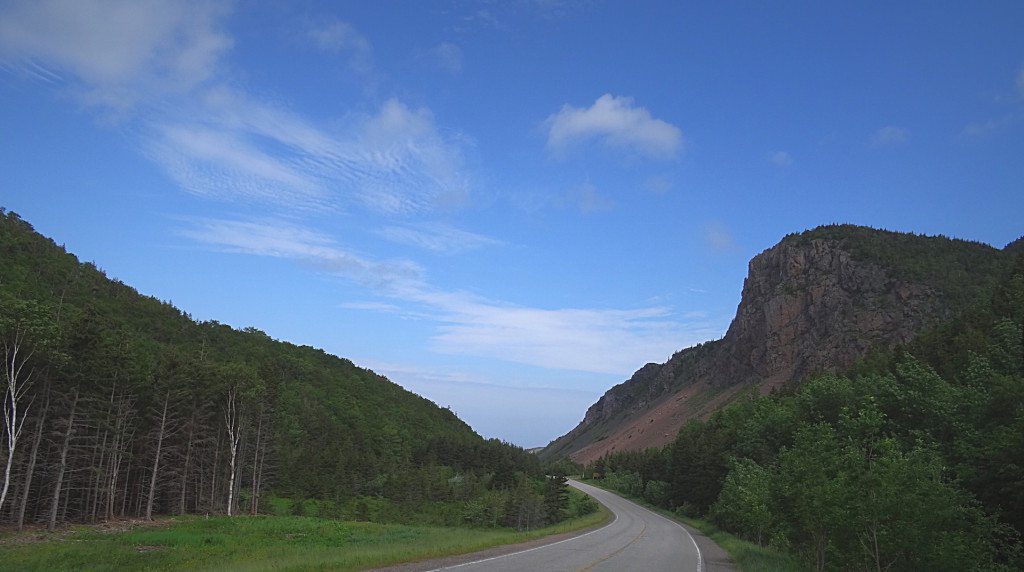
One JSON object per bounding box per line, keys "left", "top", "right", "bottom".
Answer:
{"left": 0, "top": 210, "right": 595, "bottom": 529}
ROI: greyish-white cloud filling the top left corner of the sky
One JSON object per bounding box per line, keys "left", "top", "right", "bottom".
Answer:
{"left": 0, "top": 0, "right": 231, "bottom": 109}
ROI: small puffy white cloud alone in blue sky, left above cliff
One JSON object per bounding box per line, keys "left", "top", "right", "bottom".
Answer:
{"left": 544, "top": 93, "right": 683, "bottom": 159}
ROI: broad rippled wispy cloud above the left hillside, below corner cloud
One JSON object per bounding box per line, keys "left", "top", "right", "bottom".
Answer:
{"left": 144, "top": 88, "right": 469, "bottom": 215}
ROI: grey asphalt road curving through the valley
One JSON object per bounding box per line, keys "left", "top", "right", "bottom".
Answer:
{"left": 423, "top": 481, "right": 708, "bottom": 572}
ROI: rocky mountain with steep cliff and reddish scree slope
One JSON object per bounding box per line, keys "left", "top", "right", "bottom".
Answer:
{"left": 541, "top": 225, "right": 1021, "bottom": 463}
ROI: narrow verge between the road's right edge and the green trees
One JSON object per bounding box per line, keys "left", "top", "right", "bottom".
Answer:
{"left": 581, "top": 479, "right": 809, "bottom": 572}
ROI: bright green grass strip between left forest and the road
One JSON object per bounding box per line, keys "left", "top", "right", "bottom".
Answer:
{"left": 0, "top": 507, "right": 610, "bottom": 570}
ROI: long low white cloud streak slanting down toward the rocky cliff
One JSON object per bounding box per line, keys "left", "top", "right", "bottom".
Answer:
{"left": 190, "top": 219, "right": 721, "bottom": 376}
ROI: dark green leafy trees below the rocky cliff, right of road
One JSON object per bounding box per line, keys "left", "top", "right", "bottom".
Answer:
{"left": 587, "top": 249, "right": 1024, "bottom": 570}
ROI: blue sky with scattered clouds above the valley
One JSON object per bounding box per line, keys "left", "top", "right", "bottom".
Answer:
{"left": 0, "top": 0, "right": 1024, "bottom": 446}
